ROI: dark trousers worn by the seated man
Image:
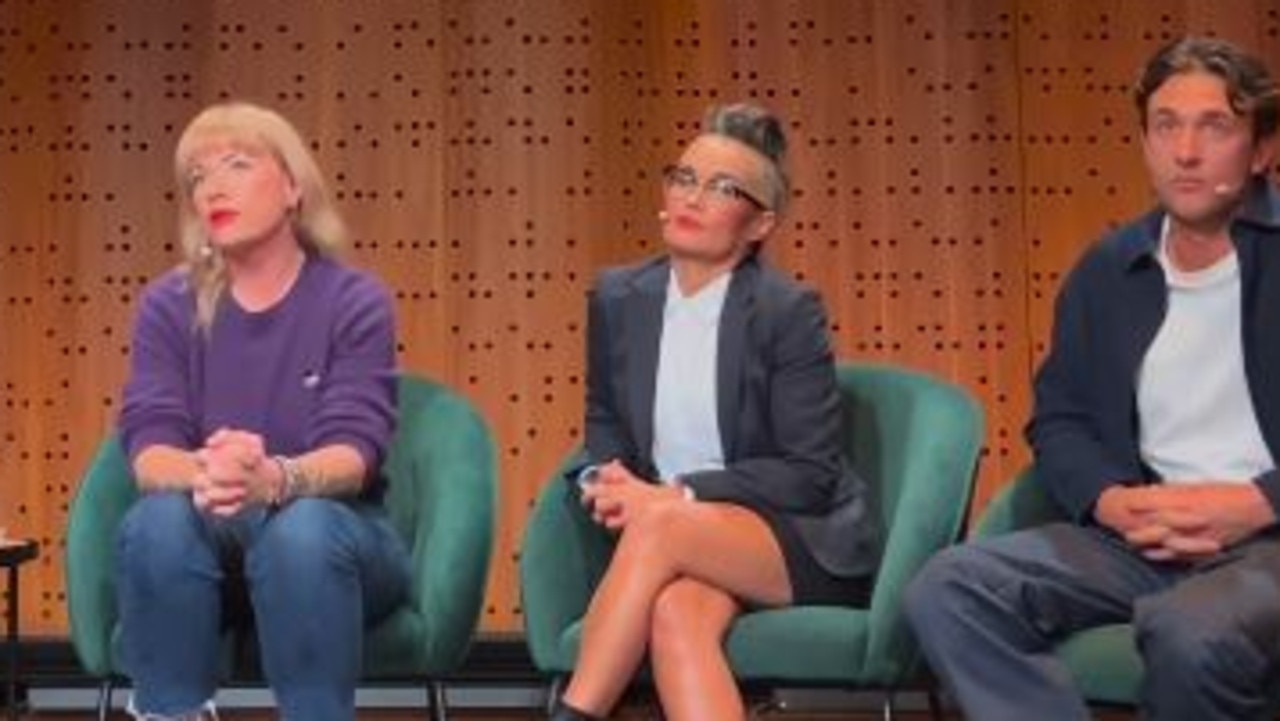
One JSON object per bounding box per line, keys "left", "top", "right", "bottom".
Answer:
{"left": 906, "top": 524, "right": 1280, "bottom": 721}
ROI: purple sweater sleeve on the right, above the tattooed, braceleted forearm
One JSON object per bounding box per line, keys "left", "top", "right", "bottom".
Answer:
{"left": 307, "top": 274, "right": 396, "bottom": 475}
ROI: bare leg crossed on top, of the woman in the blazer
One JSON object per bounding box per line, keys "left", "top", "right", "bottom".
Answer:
{"left": 564, "top": 502, "right": 791, "bottom": 716}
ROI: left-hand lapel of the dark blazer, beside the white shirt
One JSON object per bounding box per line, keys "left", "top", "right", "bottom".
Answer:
{"left": 622, "top": 263, "right": 671, "bottom": 466}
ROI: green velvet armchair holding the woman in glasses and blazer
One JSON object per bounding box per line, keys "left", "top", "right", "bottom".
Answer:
{"left": 520, "top": 364, "right": 983, "bottom": 717}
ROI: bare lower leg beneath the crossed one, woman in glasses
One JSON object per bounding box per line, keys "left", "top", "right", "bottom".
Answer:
{"left": 649, "top": 578, "right": 746, "bottom": 721}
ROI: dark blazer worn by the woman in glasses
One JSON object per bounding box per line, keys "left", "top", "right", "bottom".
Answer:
{"left": 586, "top": 254, "right": 879, "bottom": 576}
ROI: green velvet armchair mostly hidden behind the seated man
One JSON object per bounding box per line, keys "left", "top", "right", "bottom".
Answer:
{"left": 973, "top": 467, "right": 1142, "bottom": 706}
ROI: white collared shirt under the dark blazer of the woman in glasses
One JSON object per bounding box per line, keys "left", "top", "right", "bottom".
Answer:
{"left": 653, "top": 270, "right": 732, "bottom": 483}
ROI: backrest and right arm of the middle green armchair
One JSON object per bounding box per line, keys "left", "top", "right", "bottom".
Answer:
{"left": 838, "top": 364, "right": 984, "bottom": 680}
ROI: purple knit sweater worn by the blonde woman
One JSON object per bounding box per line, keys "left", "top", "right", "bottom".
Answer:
{"left": 119, "top": 255, "right": 396, "bottom": 496}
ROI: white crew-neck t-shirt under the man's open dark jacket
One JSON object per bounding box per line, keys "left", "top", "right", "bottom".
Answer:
{"left": 1138, "top": 219, "right": 1275, "bottom": 483}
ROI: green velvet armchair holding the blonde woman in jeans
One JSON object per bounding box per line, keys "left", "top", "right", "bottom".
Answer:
{"left": 65, "top": 375, "right": 497, "bottom": 720}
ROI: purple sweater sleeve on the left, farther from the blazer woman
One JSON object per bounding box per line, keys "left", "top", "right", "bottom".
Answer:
{"left": 119, "top": 273, "right": 200, "bottom": 462}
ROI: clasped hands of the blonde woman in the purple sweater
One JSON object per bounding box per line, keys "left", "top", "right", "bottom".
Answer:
{"left": 191, "top": 428, "right": 284, "bottom": 517}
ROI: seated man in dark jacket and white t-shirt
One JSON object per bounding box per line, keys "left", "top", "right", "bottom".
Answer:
{"left": 908, "top": 38, "right": 1280, "bottom": 721}
